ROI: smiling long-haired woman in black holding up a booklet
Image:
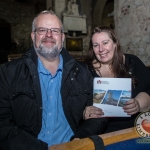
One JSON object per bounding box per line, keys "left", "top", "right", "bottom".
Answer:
{"left": 84, "top": 27, "right": 150, "bottom": 133}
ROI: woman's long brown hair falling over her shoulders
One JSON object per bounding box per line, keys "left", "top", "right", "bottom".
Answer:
{"left": 86, "top": 26, "right": 130, "bottom": 78}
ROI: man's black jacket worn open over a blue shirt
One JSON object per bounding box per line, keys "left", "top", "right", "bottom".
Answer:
{"left": 0, "top": 48, "right": 105, "bottom": 150}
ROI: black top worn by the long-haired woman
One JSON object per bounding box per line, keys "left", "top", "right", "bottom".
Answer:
{"left": 90, "top": 54, "right": 150, "bottom": 133}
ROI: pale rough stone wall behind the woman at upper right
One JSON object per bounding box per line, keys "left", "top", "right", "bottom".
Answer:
{"left": 114, "top": 0, "right": 150, "bottom": 66}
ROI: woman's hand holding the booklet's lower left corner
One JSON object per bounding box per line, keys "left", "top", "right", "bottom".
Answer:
{"left": 83, "top": 106, "right": 104, "bottom": 120}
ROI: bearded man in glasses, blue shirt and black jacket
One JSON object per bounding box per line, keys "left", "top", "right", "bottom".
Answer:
{"left": 0, "top": 11, "right": 106, "bottom": 150}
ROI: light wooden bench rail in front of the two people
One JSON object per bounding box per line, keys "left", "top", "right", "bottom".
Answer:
{"left": 50, "top": 128, "right": 139, "bottom": 150}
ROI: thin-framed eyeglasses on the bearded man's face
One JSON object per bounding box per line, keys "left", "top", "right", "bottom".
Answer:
{"left": 34, "top": 28, "right": 62, "bottom": 35}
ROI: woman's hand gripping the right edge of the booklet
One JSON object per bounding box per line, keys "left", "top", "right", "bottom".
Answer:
{"left": 123, "top": 98, "right": 140, "bottom": 115}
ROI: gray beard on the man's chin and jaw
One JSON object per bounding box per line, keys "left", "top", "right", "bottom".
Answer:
{"left": 33, "top": 37, "right": 62, "bottom": 60}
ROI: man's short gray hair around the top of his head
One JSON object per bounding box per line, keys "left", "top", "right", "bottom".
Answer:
{"left": 32, "top": 10, "right": 63, "bottom": 32}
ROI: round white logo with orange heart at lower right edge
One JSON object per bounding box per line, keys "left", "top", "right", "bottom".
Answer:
{"left": 135, "top": 111, "right": 150, "bottom": 139}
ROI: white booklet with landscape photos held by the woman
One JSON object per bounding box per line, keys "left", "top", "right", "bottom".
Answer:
{"left": 93, "top": 78, "right": 131, "bottom": 117}
